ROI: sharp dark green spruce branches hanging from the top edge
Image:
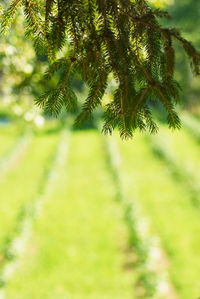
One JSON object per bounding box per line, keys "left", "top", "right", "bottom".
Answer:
{"left": 1, "top": 0, "right": 200, "bottom": 138}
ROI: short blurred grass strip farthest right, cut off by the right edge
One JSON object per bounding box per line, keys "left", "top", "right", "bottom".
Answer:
{"left": 150, "top": 127, "right": 200, "bottom": 207}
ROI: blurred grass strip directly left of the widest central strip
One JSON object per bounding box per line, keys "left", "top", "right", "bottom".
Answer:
{"left": 0, "top": 134, "right": 57, "bottom": 248}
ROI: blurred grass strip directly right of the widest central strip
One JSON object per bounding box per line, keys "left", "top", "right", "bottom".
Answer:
{"left": 116, "top": 135, "right": 200, "bottom": 299}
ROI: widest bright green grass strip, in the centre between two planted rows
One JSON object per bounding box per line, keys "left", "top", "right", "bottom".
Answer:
{"left": 3, "top": 131, "right": 133, "bottom": 299}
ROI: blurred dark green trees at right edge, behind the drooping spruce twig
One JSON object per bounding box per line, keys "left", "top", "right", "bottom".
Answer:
{"left": 169, "top": 0, "right": 200, "bottom": 110}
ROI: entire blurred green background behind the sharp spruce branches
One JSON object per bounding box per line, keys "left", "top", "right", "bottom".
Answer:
{"left": 0, "top": 0, "right": 200, "bottom": 299}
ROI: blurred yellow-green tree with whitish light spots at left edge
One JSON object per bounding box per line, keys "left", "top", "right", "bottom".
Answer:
{"left": 0, "top": 8, "right": 47, "bottom": 112}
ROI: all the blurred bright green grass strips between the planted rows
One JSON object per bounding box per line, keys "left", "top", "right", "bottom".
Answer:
{"left": 0, "top": 120, "right": 200, "bottom": 299}
